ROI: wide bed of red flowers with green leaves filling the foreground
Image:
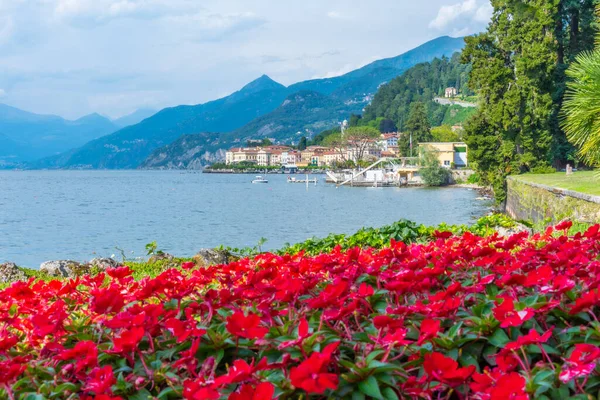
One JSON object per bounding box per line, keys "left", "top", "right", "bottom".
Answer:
{"left": 0, "top": 223, "right": 600, "bottom": 400}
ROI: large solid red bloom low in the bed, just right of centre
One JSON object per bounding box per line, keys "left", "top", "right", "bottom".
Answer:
{"left": 290, "top": 342, "right": 340, "bottom": 394}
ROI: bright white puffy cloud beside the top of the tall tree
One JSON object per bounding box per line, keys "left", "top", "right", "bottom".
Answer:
{"left": 429, "top": 0, "right": 493, "bottom": 31}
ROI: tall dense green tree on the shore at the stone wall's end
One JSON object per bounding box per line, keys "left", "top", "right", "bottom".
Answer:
{"left": 462, "top": 0, "right": 594, "bottom": 201}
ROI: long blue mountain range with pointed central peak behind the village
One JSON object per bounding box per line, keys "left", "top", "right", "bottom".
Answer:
{"left": 14, "top": 36, "right": 464, "bottom": 169}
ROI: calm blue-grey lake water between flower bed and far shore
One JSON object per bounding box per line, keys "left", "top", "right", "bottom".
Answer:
{"left": 0, "top": 171, "right": 490, "bottom": 268}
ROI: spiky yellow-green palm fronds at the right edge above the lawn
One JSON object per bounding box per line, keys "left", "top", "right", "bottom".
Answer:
{"left": 561, "top": 8, "right": 600, "bottom": 167}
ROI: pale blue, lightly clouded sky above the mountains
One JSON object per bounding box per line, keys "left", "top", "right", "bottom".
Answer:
{"left": 0, "top": 0, "right": 492, "bottom": 119}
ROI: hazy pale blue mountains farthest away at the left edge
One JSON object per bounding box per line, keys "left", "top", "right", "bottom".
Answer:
{"left": 0, "top": 104, "right": 118, "bottom": 164}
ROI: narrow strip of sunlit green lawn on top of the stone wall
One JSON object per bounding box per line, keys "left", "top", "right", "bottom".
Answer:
{"left": 517, "top": 171, "right": 600, "bottom": 196}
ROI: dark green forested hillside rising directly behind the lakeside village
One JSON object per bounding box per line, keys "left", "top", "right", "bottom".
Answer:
{"left": 363, "top": 53, "right": 473, "bottom": 131}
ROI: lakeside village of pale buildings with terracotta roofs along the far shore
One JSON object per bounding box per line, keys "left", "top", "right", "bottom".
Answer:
{"left": 205, "top": 121, "right": 472, "bottom": 187}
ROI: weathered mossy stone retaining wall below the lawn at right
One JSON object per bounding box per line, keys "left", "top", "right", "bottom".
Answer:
{"left": 505, "top": 176, "right": 600, "bottom": 224}
